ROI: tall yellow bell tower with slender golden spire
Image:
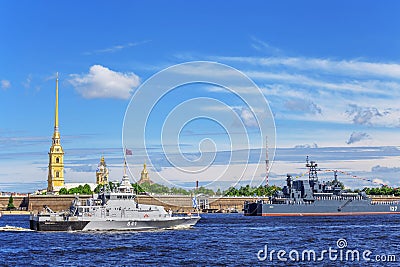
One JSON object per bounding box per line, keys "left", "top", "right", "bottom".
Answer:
{"left": 47, "top": 73, "right": 64, "bottom": 192}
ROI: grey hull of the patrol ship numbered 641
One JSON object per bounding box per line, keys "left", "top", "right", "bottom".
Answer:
{"left": 30, "top": 216, "right": 200, "bottom": 231}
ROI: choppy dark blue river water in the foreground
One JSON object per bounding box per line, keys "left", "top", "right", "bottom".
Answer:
{"left": 0, "top": 214, "right": 400, "bottom": 266}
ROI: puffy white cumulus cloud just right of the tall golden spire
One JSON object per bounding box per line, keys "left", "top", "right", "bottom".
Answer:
{"left": 69, "top": 65, "right": 140, "bottom": 99}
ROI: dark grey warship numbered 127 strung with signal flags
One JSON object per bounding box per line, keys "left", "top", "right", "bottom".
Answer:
{"left": 243, "top": 157, "right": 400, "bottom": 216}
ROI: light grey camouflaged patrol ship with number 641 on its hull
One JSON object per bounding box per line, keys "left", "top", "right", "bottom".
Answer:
{"left": 30, "top": 165, "right": 200, "bottom": 231}
